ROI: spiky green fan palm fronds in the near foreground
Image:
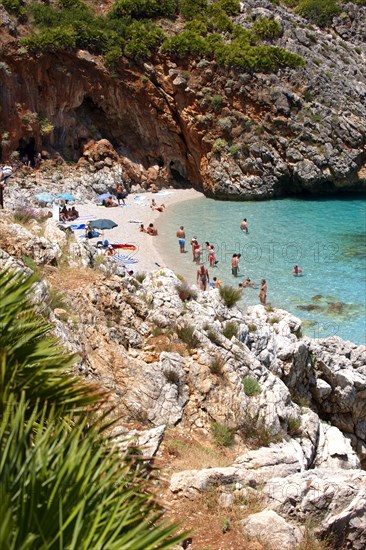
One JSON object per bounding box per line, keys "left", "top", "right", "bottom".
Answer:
{"left": 0, "top": 272, "right": 181, "bottom": 550}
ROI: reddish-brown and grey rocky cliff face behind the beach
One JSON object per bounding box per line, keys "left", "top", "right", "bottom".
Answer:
{"left": 0, "top": 0, "right": 366, "bottom": 200}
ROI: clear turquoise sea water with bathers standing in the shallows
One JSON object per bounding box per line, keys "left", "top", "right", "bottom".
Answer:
{"left": 157, "top": 198, "right": 366, "bottom": 344}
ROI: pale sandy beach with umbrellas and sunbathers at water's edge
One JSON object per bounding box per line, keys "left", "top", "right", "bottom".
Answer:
{"left": 73, "top": 189, "right": 203, "bottom": 272}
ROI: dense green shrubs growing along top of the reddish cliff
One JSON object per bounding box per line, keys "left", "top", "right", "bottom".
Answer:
{"left": 0, "top": 0, "right": 304, "bottom": 71}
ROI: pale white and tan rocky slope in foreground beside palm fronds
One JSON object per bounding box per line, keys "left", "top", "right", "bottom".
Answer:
{"left": 0, "top": 210, "right": 366, "bottom": 550}
